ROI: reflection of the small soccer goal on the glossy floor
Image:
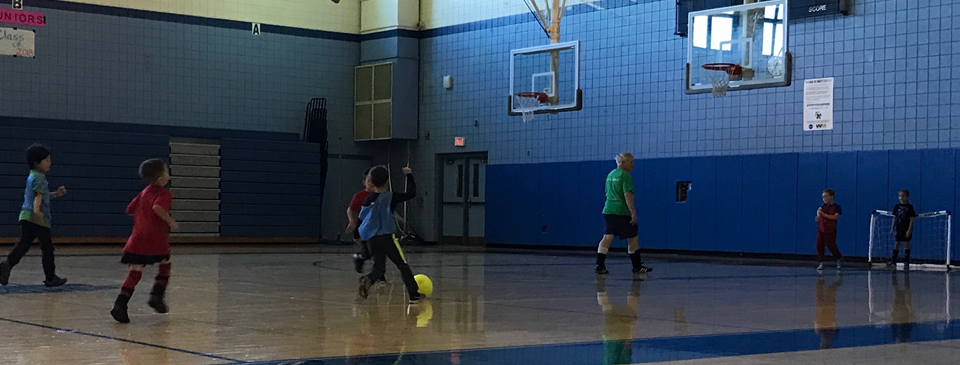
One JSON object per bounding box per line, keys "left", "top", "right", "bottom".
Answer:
{"left": 867, "top": 271, "right": 953, "bottom": 331}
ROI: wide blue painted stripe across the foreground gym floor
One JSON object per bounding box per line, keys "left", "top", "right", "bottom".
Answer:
{"left": 216, "top": 320, "right": 960, "bottom": 365}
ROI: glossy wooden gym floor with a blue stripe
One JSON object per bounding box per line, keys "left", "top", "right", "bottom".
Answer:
{"left": 0, "top": 246, "right": 960, "bottom": 365}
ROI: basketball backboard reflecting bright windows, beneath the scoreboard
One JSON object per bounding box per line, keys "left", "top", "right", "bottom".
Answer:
{"left": 685, "top": 0, "right": 792, "bottom": 96}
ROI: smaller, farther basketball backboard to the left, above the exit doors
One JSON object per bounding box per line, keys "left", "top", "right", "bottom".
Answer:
{"left": 507, "top": 41, "right": 583, "bottom": 116}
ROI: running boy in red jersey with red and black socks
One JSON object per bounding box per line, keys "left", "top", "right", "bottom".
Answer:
{"left": 110, "top": 159, "right": 179, "bottom": 323}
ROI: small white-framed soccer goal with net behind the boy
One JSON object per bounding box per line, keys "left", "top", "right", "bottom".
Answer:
{"left": 868, "top": 210, "right": 952, "bottom": 271}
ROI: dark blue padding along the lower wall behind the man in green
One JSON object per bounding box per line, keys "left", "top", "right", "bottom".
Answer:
{"left": 486, "top": 149, "right": 960, "bottom": 259}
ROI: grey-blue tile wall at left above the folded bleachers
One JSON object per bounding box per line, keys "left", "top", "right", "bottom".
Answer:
{"left": 0, "top": 6, "right": 360, "bottom": 140}
